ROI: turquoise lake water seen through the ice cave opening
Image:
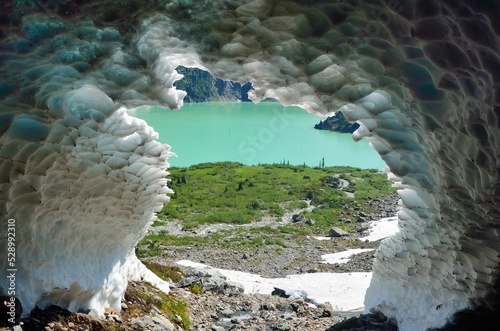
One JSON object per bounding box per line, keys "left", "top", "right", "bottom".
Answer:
{"left": 129, "top": 102, "right": 385, "bottom": 169}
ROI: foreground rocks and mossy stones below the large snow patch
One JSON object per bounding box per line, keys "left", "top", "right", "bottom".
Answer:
{"left": 5, "top": 275, "right": 397, "bottom": 331}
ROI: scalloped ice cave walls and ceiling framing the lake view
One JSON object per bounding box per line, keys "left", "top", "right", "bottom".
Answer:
{"left": 0, "top": 0, "right": 500, "bottom": 330}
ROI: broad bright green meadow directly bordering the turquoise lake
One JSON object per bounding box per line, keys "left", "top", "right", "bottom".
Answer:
{"left": 158, "top": 162, "right": 394, "bottom": 229}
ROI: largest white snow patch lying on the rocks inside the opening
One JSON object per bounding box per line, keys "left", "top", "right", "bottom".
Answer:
{"left": 176, "top": 260, "right": 372, "bottom": 311}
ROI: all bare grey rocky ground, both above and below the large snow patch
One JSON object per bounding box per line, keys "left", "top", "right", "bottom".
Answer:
{"left": 0, "top": 196, "right": 398, "bottom": 331}
